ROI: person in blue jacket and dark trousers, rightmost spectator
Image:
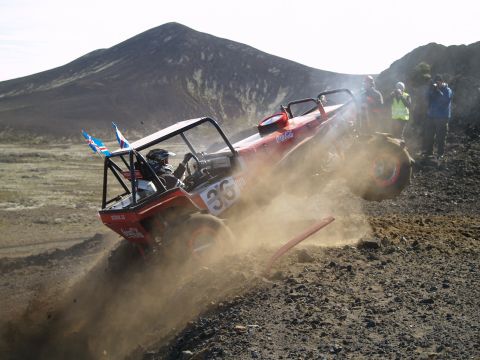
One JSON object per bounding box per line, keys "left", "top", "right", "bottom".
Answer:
{"left": 424, "top": 75, "right": 453, "bottom": 161}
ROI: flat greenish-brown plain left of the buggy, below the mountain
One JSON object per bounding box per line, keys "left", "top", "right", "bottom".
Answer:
{"left": 0, "top": 143, "right": 107, "bottom": 257}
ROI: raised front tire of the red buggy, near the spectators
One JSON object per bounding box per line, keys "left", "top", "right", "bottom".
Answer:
{"left": 346, "top": 134, "right": 412, "bottom": 201}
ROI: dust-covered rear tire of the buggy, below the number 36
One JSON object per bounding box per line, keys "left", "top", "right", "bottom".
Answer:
{"left": 165, "top": 214, "right": 234, "bottom": 262}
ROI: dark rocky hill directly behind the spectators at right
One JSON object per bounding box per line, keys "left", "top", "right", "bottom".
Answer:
{"left": 377, "top": 41, "right": 480, "bottom": 124}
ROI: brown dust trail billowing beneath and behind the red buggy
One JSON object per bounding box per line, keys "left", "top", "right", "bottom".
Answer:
{"left": 2, "top": 144, "right": 376, "bottom": 359}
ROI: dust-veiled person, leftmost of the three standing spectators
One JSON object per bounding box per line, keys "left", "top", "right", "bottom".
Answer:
{"left": 361, "top": 75, "right": 383, "bottom": 132}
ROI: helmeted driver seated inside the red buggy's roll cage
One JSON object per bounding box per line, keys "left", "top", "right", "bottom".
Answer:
{"left": 147, "top": 149, "right": 190, "bottom": 190}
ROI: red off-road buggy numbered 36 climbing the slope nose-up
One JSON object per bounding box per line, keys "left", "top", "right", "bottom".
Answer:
{"left": 99, "top": 89, "right": 411, "bottom": 264}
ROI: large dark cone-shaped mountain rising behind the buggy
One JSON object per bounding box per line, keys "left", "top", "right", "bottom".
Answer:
{"left": 0, "top": 23, "right": 361, "bottom": 136}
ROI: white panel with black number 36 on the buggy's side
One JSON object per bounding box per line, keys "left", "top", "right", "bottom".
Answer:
{"left": 200, "top": 177, "right": 240, "bottom": 215}
